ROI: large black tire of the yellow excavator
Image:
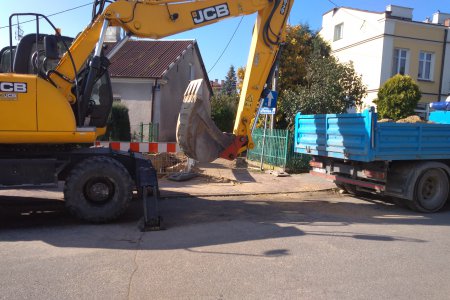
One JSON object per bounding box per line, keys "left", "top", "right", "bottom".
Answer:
{"left": 64, "top": 156, "right": 133, "bottom": 223}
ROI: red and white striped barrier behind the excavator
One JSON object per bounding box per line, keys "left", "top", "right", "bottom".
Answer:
{"left": 95, "top": 141, "right": 181, "bottom": 153}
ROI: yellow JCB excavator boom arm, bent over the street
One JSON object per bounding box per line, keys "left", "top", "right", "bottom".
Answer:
{"left": 51, "top": 0, "right": 293, "bottom": 162}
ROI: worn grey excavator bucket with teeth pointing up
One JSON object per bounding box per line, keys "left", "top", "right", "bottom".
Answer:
{"left": 177, "top": 79, "right": 235, "bottom": 162}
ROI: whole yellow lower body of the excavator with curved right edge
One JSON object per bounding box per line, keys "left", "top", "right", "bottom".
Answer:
{"left": 0, "top": 74, "right": 96, "bottom": 144}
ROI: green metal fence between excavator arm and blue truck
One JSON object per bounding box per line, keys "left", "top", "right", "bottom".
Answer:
{"left": 247, "top": 128, "right": 310, "bottom": 171}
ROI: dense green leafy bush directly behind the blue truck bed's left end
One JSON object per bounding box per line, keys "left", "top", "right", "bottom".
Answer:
{"left": 280, "top": 57, "right": 366, "bottom": 127}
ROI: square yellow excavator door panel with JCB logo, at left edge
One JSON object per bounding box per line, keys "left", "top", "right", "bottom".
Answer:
{"left": 0, "top": 73, "right": 37, "bottom": 134}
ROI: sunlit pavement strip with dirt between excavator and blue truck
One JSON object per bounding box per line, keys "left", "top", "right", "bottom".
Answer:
{"left": 159, "top": 159, "right": 336, "bottom": 197}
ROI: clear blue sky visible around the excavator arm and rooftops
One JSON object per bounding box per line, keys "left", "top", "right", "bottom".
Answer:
{"left": 0, "top": 0, "right": 450, "bottom": 79}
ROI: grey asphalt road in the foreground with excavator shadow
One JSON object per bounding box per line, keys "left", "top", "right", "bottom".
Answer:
{"left": 0, "top": 193, "right": 450, "bottom": 299}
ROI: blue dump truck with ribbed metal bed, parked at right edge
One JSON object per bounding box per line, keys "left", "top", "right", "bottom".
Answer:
{"left": 294, "top": 109, "right": 450, "bottom": 212}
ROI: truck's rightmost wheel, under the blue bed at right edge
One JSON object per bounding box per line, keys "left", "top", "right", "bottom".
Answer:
{"left": 409, "top": 168, "right": 449, "bottom": 213}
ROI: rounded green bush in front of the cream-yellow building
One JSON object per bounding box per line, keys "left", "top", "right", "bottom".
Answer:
{"left": 374, "top": 74, "right": 422, "bottom": 120}
